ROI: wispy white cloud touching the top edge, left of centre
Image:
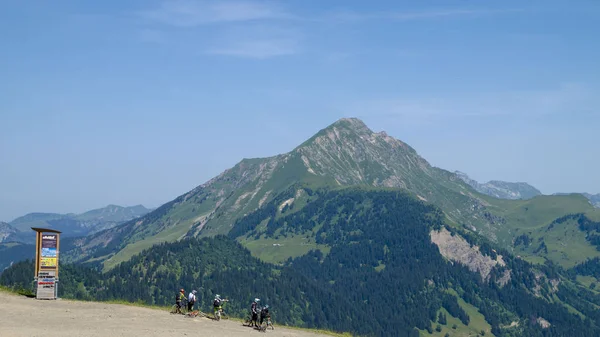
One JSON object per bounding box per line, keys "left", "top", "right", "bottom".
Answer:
{"left": 138, "top": 0, "right": 289, "bottom": 27}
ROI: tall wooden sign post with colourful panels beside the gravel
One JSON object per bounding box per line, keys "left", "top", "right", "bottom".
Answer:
{"left": 31, "top": 227, "right": 61, "bottom": 300}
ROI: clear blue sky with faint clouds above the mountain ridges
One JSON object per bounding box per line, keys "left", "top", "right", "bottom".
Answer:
{"left": 0, "top": 0, "right": 600, "bottom": 221}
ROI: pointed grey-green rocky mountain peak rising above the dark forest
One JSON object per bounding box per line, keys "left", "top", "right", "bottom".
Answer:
{"left": 66, "top": 118, "right": 593, "bottom": 269}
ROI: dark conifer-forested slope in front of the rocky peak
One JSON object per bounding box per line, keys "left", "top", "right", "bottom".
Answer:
{"left": 0, "top": 189, "right": 600, "bottom": 337}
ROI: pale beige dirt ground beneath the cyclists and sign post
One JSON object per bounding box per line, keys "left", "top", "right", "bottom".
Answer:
{"left": 0, "top": 292, "right": 324, "bottom": 337}
